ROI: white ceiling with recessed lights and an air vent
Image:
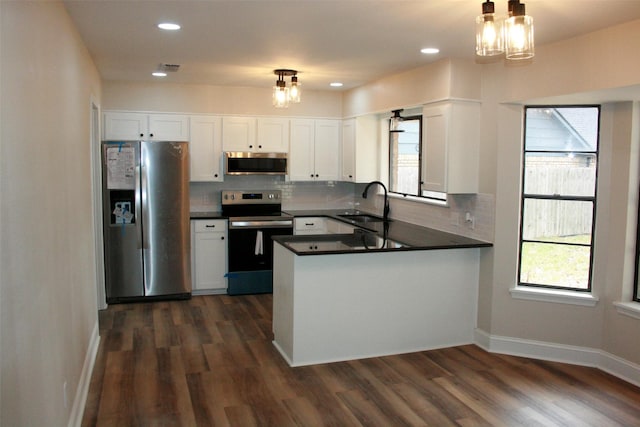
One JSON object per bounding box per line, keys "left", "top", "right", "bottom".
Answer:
{"left": 64, "top": 0, "right": 640, "bottom": 90}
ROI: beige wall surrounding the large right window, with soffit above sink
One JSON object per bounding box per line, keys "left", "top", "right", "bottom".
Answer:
{"left": 343, "top": 21, "right": 640, "bottom": 363}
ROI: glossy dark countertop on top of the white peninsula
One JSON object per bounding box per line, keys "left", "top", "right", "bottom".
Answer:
{"left": 273, "top": 209, "right": 493, "bottom": 255}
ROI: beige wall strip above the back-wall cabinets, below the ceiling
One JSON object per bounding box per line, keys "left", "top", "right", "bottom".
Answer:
{"left": 102, "top": 81, "right": 342, "bottom": 118}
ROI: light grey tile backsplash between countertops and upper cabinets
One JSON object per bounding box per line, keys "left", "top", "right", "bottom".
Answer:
{"left": 190, "top": 175, "right": 495, "bottom": 242}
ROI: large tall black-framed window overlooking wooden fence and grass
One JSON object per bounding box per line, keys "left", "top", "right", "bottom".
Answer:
{"left": 518, "top": 106, "right": 600, "bottom": 292}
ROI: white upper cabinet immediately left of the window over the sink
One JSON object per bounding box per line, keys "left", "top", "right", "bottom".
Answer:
{"left": 341, "top": 116, "right": 380, "bottom": 182}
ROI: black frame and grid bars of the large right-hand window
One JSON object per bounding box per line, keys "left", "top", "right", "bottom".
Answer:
{"left": 516, "top": 104, "right": 604, "bottom": 293}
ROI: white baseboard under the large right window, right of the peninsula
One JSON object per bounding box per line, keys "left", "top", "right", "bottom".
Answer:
{"left": 475, "top": 329, "right": 640, "bottom": 387}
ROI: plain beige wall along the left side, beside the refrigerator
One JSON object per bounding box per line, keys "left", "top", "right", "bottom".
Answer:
{"left": 0, "top": 1, "right": 100, "bottom": 426}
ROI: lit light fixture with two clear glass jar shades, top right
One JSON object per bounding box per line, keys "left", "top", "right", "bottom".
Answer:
{"left": 476, "top": 0, "right": 534, "bottom": 60}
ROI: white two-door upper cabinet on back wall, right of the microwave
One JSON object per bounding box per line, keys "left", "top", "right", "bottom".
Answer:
{"left": 289, "top": 119, "right": 340, "bottom": 181}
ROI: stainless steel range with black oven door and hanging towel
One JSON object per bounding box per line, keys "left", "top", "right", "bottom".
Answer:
{"left": 222, "top": 190, "right": 293, "bottom": 295}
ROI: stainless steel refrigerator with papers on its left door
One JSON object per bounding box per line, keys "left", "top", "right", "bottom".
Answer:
{"left": 102, "top": 141, "right": 191, "bottom": 303}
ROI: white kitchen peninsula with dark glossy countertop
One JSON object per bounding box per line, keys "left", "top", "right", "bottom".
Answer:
{"left": 273, "top": 212, "right": 491, "bottom": 366}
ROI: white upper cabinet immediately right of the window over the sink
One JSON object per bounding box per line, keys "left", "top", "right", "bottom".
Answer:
{"left": 422, "top": 101, "right": 480, "bottom": 194}
